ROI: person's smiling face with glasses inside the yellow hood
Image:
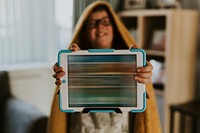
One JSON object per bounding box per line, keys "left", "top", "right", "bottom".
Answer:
{"left": 87, "top": 10, "right": 113, "bottom": 48}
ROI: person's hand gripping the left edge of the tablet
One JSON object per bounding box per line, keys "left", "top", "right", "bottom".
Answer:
{"left": 52, "top": 43, "right": 80, "bottom": 86}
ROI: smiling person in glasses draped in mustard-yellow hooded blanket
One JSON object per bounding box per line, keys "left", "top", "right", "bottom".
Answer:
{"left": 48, "top": 1, "right": 161, "bottom": 133}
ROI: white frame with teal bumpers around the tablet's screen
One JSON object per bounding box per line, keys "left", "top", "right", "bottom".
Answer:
{"left": 58, "top": 49, "right": 146, "bottom": 112}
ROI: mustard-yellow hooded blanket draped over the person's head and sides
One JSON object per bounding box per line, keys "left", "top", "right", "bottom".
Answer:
{"left": 48, "top": 1, "right": 161, "bottom": 133}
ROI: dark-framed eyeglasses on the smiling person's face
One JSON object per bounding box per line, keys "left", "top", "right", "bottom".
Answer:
{"left": 87, "top": 17, "right": 111, "bottom": 29}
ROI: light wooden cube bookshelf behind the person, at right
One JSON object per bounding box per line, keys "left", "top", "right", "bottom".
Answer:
{"left": 118, "top": 9, "right": 198, "bottom": 133}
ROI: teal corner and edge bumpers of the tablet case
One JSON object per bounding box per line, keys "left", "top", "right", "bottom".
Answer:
{"left": 58, "top": 48, "right": 146, "bottom": 113}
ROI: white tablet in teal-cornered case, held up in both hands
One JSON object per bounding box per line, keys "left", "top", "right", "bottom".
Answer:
{"left": 58, "top": 49, "right": 146, "bottom": 112}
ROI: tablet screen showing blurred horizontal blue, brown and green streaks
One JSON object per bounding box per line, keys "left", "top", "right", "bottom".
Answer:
{"left": 67, "top": 55, "right": 137, "bottom": 107}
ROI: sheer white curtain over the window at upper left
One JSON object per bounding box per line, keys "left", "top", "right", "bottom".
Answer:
{"left": 0, "top": 0, "right": 72, "bottom": 65}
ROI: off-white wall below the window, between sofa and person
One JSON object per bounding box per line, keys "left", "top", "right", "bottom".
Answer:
{"left": 9, "top": 67, "right": 55, "bottom": 115}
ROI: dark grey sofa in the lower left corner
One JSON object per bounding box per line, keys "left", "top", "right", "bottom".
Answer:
{"left": 0, "top": 71, "right": 48, "bottom": 133}
